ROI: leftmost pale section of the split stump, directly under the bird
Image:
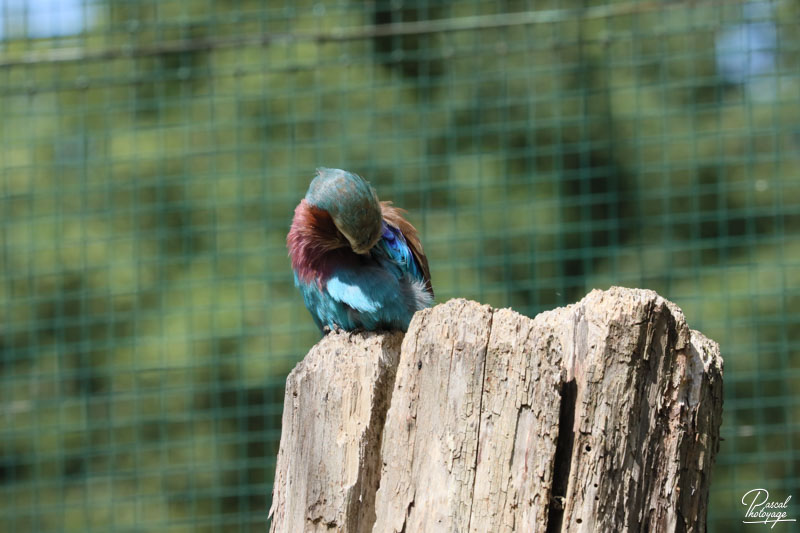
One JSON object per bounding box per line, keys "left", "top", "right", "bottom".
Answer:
{"left": 270, "top": 332, "right": 403, "bottom": 533}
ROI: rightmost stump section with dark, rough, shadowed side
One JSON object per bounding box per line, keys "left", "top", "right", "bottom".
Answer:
{"left": 548, "top": 287, "right": 722, "bottom": 531}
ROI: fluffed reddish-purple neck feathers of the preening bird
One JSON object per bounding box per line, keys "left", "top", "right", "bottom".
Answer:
{"left": 286, "top": 200, "right": 349, "bottom": 283}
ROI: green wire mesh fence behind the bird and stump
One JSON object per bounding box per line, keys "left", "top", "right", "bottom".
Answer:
{"left": 0, "top": 0, "right": 800, "bottom": 532}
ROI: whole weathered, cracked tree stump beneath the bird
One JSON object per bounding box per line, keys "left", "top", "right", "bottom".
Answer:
{"left": 270, "top": 287, "right": 722, "bottom": 533}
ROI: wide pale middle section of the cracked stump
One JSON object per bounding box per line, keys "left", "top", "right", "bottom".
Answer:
{"left": 374, "top": 300, "right": 561, "bottom": 532}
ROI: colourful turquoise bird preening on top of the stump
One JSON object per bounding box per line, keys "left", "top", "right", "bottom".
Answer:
{"left": 286, "top": 168, "right": 434, "bottom": 333}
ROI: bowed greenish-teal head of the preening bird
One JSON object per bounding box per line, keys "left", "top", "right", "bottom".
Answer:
{"left": 306, "top": 168, "right": 383, "bottom": 254}
